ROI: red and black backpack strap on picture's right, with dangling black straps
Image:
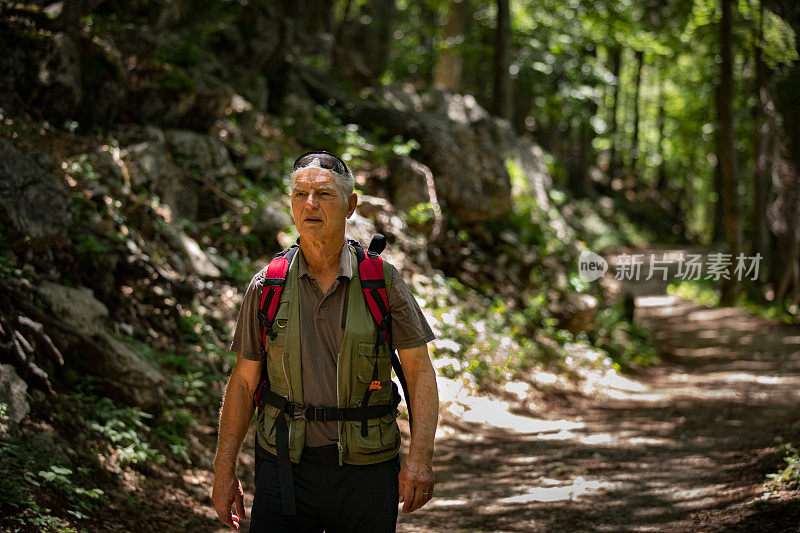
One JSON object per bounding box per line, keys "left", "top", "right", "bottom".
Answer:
{"left": 349, "top": 233, "right": 412, "bottom": 437}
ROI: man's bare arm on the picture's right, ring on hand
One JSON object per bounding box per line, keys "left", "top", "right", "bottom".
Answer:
{"left": 397, "top": 344, "right": 439, "bottom": 513}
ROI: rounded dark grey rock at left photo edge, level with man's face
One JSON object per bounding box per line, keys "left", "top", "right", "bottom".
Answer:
{"left": 0, "top": 138, "right": 72, "bottom": 249}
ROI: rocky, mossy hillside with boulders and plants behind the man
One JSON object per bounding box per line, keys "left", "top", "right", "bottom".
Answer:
{"left": 0, "top": 2, "right": 652, "bottom": 531}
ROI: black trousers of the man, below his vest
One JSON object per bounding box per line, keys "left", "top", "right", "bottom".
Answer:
{"left": 250, "top": 442, "right": 400, "bottom": 533}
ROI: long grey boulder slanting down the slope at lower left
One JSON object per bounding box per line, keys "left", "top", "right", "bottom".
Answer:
{"left": 39, "top": 281, "right": 167, "bottom": 410}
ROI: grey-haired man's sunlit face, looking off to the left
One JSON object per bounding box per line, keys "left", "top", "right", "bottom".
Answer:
{"left": 291, "top": 168, "right": 358, "bottom": 240}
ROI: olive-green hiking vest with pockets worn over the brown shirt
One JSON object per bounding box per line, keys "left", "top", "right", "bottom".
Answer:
{"left": 256, "top": 244, "right": 400, "bottom": 466}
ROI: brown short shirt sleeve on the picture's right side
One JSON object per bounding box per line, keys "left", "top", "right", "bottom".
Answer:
{"left": 389, "top": 266, "right": 435, "bottom": 349}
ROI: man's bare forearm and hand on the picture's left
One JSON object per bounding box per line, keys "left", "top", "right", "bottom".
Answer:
{"left": 211, "top": 354, "right": 262, "bottom": 529}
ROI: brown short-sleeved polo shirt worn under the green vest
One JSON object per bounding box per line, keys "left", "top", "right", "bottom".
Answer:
{"left": 230, "top": 246, "right": 434, "bottom": 446}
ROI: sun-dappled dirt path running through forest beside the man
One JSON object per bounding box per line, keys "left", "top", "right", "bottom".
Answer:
{"left": 398, "top": 244, "right": 800, "bottom": 533}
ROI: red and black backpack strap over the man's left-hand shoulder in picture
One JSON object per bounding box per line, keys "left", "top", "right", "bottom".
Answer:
{"left": 253, "top": 245, "right": 298, "bottom": 407}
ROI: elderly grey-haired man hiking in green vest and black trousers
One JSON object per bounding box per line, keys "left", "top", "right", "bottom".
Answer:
{"left": 212, "top": 151, "right": 439, "bottom": 533}
